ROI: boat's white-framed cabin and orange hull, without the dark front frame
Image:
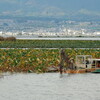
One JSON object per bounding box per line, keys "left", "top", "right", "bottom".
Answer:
{"left": 68, "top": 55, "right": 100, "bottom": 73}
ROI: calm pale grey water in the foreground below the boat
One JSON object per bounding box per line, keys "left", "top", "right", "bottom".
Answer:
{"left": 0, "top": 73, "right": 100, "bottom": 100}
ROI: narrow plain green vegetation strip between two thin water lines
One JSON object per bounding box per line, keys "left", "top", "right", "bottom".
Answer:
{"left": 0, "top": 40, "right": 100, "bottom": 48}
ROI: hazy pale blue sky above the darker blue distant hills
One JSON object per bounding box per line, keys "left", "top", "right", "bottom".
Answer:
{"left": 0, "top": 0, "right": 100, "bottom": 17}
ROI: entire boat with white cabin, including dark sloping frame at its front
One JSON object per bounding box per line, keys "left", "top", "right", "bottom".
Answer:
{"left": 60, "top": 50, "right": 100, "bottom": 74}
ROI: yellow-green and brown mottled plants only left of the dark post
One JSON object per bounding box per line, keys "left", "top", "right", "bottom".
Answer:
{"left": 0, "top": 49, "right": 59, "bottom": 72}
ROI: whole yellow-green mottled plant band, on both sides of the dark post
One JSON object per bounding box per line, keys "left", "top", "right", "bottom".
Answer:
{"left": 0, "top": 49, "right": 100, "bottom": 72}
